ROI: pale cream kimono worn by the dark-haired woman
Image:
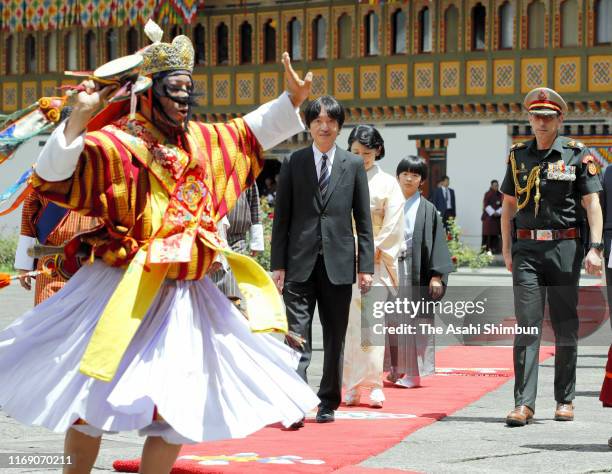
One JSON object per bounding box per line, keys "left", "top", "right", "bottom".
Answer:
{"left": 342, "top": 165, "right": 404, "bottom": 401}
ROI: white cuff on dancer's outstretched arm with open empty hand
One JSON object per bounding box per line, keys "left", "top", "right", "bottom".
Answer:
{"left": 244, "top": 92, "right": 304, "bottom": 150}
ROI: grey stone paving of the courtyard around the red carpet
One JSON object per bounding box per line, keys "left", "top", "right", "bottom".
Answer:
{"left": 0, "top": 267, "right": 612, "bottom": 474}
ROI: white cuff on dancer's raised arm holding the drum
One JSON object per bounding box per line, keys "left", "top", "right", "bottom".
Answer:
{"left": 36, "top": 122, "right": 85, "bottom": 182}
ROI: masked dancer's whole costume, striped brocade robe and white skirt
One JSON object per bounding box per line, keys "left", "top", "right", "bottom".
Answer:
{"left": 0, "top": 94, "right": 318, "bottom": 444}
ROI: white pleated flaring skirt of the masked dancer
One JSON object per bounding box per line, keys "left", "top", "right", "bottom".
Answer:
{"left": 0, "top": 261, "right": 319, "bottom": 443}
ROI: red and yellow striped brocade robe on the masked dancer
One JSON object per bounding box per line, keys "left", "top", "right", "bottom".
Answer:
{"left": 33, "top": 115, "right": 263, "bottom": 280}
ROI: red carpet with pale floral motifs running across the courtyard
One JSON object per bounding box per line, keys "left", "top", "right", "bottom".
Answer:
{"left": 113, "top": 346, "right": 554, "bottom": 474}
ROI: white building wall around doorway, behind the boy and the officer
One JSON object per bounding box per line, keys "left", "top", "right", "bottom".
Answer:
{"left": 338, "top": 124, "right": 512, "bottom": 247}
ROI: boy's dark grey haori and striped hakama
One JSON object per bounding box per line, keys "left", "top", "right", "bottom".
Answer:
{"left": 385, "top": 196, "right": 454, "bottom": 377}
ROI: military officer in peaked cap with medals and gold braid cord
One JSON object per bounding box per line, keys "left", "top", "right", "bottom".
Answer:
{"left": 501, "top": 87, "right": 603, "bottom": 426}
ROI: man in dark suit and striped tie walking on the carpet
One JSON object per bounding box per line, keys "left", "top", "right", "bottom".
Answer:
{"left": 271, "top": 96, "right": 374, "bottom": 428}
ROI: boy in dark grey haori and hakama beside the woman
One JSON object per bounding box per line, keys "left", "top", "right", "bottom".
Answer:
{"left": 385, "top": 156, "right": 453, "bottom": 388}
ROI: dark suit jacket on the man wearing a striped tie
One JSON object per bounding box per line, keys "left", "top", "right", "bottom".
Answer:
{"left": 271, "top": 147, "right": 374, "bottom": 285}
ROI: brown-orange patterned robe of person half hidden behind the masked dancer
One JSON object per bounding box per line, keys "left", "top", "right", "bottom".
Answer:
{"left": 15, "top": 191, "right": 98, "bottom": 304}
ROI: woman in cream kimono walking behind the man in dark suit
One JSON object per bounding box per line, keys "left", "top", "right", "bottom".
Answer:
{"left": 342, "top": 125, "right": 404, "bottom": 408}
